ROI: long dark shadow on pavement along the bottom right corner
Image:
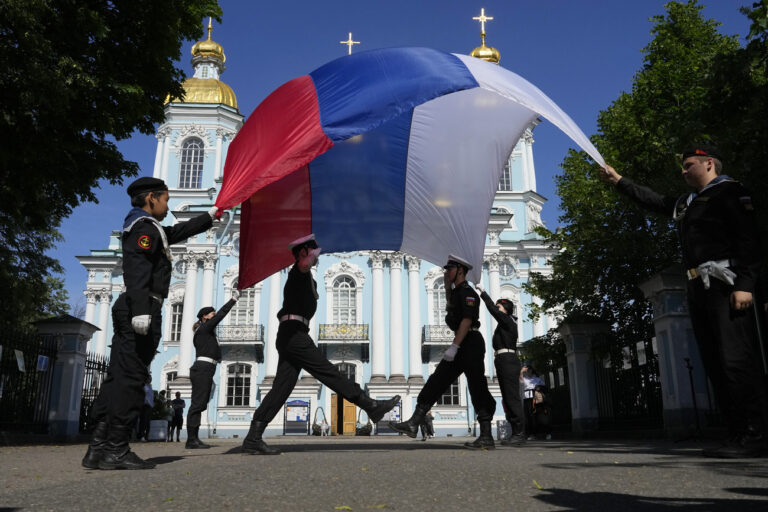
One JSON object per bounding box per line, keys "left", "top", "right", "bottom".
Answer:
{"left": 534, "top": 489, "right": 768, "bottom": 512}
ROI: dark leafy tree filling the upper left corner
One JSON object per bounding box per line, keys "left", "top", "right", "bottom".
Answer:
{"left": 0, "top": 0, "right": 221, "bottom": 323}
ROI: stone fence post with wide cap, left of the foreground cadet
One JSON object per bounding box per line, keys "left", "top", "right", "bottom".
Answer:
{"left": 35, "top": 315, "right": 99, "bottom": 440}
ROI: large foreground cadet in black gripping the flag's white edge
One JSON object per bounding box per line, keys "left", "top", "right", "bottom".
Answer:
{"left": 601, "top": 145, "right": 765, "bottom": 458}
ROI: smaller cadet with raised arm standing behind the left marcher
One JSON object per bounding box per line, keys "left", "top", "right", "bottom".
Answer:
{"left": 185, "top": 290, "right": 240, "bottom": 449}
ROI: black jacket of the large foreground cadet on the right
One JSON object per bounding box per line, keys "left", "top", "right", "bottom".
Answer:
{"left": 616, "top": 178, "right": 760, "bottom": 293}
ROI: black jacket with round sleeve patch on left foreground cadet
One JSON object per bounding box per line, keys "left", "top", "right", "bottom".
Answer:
{"left": 123, "top": 213, "right": 213, "bottom": 316}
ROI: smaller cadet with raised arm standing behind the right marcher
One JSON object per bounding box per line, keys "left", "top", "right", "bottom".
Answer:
{"left": 475, "top": 285, "right": 525, "bottom": 446}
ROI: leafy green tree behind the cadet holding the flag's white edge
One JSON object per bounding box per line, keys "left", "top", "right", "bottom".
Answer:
{"left": 528, "top": 0, "right": 768, "bottom": 344}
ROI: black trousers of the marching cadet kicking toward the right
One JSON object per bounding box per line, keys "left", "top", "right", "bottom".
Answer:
{"left": 253, "top": 320, "right": 366, "bottom": 423}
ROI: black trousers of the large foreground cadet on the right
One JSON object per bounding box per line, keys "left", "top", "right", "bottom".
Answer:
{"left": 688, "top": 278, "right": 766, "bottom": 432}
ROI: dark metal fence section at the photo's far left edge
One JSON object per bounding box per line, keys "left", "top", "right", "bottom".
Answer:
{"left": 0, "top": 333, "right": 56, "bottom": 434}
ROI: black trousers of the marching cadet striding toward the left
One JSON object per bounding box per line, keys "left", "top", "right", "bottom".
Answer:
{"left": 416, "top": 331, "right": 496, "bottom": 421}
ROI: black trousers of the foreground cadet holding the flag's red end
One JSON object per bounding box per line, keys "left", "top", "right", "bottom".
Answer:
{"left": 91, "top": 293, "right": 162, "bottom": 425}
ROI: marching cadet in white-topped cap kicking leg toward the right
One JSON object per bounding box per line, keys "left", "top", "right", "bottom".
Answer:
{"left": 243, "top": 235, "right": 400, "bottom": 455}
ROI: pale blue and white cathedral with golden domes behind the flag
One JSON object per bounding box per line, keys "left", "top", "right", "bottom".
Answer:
{"left": 78, "top": 23, "right": 563, "bottom": 437}
